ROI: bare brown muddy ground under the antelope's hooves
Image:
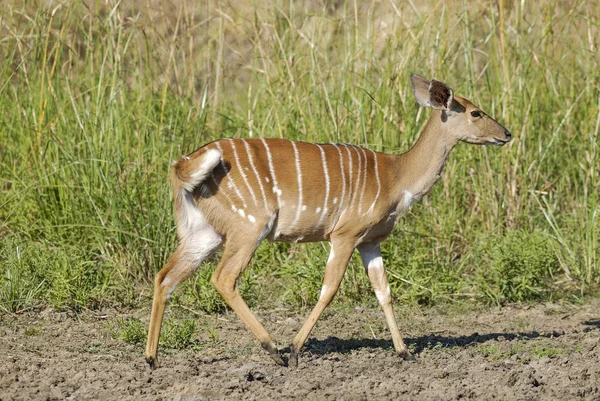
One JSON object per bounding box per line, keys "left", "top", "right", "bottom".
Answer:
{"left": 0, "top": 302, "right": 600, "bottom": 401}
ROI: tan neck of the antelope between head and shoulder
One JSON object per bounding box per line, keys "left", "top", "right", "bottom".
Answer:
{"left": 395, "top": 110, "right": 458, "bottom": 199}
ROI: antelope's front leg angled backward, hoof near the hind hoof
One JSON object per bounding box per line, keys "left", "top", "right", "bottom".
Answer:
{"left": 289, "top": 239, "right": 354, "bottom": 367}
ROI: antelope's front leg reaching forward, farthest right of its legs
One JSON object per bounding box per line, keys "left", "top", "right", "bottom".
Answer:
{"left": 358, "top": 244, "right": 415, "bottom": 361}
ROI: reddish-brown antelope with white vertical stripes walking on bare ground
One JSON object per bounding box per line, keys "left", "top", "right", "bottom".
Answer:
{"left": 145, "top": 74, "right": 511, "bottom": 369}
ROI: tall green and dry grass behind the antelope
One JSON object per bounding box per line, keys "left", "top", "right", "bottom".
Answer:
{"left": 0, "top": 0, "right": 600, "bottom": 311}
